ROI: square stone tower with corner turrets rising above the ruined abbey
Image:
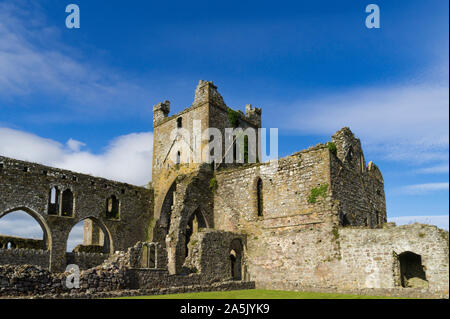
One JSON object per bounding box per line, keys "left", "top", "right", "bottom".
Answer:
{"left": 152, "top": 80, "right": 261, "bottom": 222}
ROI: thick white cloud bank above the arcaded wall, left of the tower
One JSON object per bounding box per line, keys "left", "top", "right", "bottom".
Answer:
{"left": 0, "top": 127, "right": 153, "bottom": 186}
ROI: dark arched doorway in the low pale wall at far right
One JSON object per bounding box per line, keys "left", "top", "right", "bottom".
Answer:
{"left": 398, "top": 251, "right": 428, "bottom": 288}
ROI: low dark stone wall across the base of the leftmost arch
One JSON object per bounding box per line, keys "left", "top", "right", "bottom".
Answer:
{"left": 0, "top": 248, "right": 50, "bottom": 269}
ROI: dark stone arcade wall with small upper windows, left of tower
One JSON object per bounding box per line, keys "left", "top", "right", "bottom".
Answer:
{"left": 0, "top": 157, "right": 153, "bottom": 271}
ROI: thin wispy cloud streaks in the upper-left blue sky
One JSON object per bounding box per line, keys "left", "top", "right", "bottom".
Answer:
{"left": 0, "top": 1, "right": 150, "bottom": 121}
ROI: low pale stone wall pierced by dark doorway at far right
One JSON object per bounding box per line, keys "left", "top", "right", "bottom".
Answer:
{"left": 335, "top": 224, "right": 449, "bottom": 294}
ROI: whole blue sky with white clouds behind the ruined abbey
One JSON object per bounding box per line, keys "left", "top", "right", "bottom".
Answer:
{"left": 0, "top": 0, "right": 449, "bottom": 248}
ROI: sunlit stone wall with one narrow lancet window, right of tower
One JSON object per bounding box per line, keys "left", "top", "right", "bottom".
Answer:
{"left": 214, "top": 145, "right": 339, "bottom": 287}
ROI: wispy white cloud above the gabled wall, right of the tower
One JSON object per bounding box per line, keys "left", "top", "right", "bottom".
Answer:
{"left": 286, "top": 81, "right": 449, "bottom": 164}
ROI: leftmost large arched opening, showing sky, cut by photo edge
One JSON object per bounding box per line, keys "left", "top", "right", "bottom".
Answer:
{"left": 0, "top": 208, "right": 51, "bottom": 250}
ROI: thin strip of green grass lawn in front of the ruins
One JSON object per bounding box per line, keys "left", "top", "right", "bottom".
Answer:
{"left": 119, "top": 289, "right": 408, "bottom": 299}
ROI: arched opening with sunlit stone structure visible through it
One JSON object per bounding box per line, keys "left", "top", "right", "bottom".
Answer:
{"left": 66, "top": 217, "right": 112, "bottom": 254}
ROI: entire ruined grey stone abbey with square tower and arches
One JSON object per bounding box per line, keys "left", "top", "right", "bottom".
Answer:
{"left": 0, "top": 81, "right": 449, "bottom": 297}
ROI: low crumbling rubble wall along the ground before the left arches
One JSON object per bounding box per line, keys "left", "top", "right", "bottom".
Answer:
{"left": 0, "top": 243, "right": 254, "bottom": 298}
